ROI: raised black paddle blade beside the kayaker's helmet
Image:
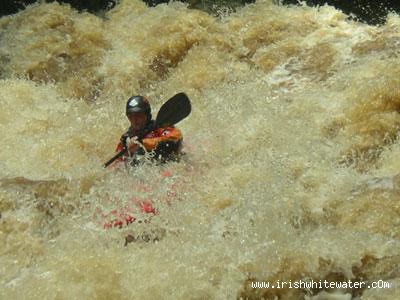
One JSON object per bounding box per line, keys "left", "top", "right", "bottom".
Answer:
{"left": 156, "top": 93, "right": 192, "bottom": 127}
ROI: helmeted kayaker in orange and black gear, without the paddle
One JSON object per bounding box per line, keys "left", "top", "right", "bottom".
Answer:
{"left": 112, "top": 96, "right": 182, "bottom": 165}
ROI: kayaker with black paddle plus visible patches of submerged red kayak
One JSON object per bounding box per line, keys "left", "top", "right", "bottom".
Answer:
{"left": 101, "top": 92, "right": 192, "bottom": 230}
